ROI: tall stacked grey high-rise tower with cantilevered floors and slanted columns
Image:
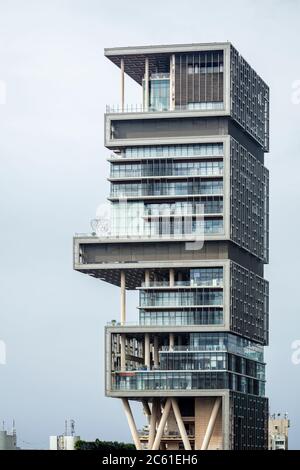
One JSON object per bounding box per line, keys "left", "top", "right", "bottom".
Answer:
{"left": 74, "top": 43, "right": 269, "bottom": 450}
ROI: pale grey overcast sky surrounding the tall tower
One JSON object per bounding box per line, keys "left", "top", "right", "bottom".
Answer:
{"left": 0, "top": 0, "right": 300, "bottom": 448}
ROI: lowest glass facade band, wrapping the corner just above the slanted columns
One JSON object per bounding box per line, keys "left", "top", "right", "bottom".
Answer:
{"left": 112, "top": 332, "right": 265, "bottom": 395}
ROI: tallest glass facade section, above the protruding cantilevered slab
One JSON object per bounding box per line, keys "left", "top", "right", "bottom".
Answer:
{"left": 110, "top": 143, "right": 224, "bottom": 237}
